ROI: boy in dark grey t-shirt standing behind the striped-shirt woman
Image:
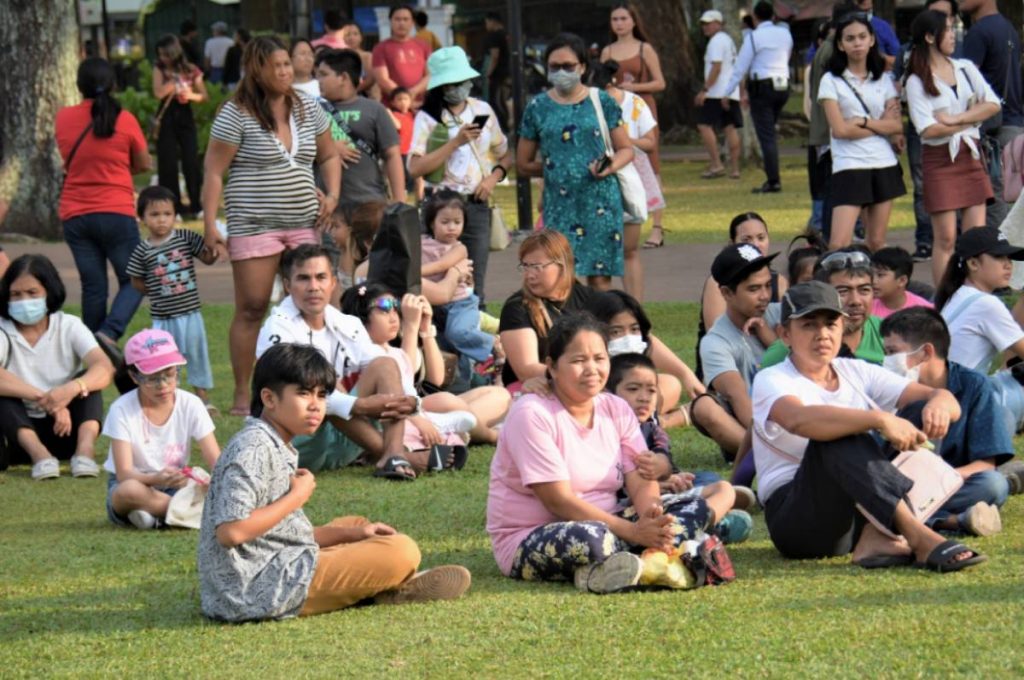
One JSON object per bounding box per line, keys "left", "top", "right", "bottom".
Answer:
{"left": 315, "top": 49, "right": 406, "bottom": 204}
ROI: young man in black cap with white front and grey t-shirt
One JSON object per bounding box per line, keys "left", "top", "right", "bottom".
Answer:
{"left": 693, "top": 244, "right": 777, "bottom": 460}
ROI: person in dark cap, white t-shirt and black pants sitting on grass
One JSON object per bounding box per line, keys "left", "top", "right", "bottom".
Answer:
{"left": 752, "top": 281, "right": 985, "bottom": 571}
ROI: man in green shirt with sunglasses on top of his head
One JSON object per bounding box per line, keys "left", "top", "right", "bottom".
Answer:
{"left": 761, "top": 248, "right": 885, "bottom": 369}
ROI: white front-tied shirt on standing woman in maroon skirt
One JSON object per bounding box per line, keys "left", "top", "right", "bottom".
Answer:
{"left": 906, "top": 59, "right": 999, "bottom": 160}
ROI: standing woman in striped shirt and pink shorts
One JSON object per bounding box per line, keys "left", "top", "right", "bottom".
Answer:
{"left": 203, "top": 36, "right": 341, "bottom": 416}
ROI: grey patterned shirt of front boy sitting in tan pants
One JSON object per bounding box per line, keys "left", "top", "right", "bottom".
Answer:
{"left": 199, "top": 418, "right": 319, "bottom": 622}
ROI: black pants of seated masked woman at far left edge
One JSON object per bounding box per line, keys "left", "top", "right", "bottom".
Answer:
{"left": 0, "top": 391, "right": 103, "bottom": 470}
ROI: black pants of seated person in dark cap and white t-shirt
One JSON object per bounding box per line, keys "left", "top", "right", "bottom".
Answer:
{"left": 765, "top": 434, "right": 913, "bottom": 559}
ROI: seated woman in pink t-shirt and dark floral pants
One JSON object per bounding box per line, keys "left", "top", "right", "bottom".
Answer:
{"left": 487, "top": 312, "right": 714, "bottom": 593}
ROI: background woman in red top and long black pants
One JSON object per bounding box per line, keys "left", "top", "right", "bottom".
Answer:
{"left": 153, "top": 35, "right": 207, "bottom": 217}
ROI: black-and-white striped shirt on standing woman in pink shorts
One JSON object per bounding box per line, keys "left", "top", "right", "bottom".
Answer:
{"left": 210, "top": 93, "right": 330, "bottom": 237}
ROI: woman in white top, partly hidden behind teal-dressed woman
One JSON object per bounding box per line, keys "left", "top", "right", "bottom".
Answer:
{"left": 590, "top": 59, "right": 665, "bottom": 302}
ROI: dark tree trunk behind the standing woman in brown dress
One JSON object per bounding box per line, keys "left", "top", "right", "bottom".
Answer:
{"left": 635, "top": 0, "right": 701, "bottom": 131}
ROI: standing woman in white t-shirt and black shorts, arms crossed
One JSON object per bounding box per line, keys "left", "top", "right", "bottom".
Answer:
{"left": 818, "top": 12, "right": 906, "bottom": 251}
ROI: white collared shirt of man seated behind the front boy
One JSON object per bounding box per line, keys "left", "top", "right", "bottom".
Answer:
{"left": 256, "top": 295, "right": 385, "bottom": 420}
